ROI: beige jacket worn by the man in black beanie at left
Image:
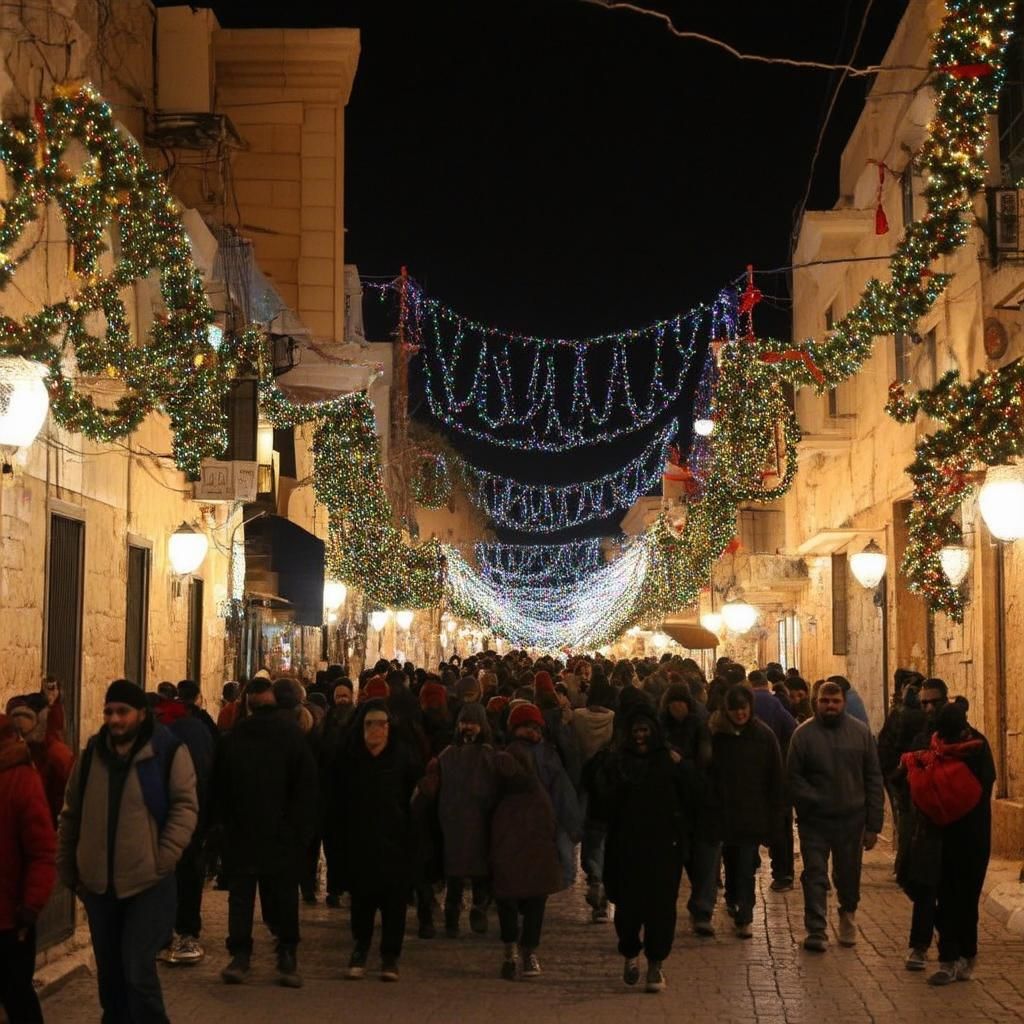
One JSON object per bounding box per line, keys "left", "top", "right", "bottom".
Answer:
{"left": 57, "top": 717, "right": 199, "bottom": 899}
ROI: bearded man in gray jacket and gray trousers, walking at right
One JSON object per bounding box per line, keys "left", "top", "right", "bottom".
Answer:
{"left": 786, "top": 682, "right": 884, "bottom": 952}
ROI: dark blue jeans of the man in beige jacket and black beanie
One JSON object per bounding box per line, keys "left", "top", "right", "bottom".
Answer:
{"left": 82, "top": 874, "right": 177, "bottom": 1024}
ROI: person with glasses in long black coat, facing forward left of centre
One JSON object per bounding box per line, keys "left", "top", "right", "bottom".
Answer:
{"left": 332, "top": 700, "right": 422, "bottom": 981}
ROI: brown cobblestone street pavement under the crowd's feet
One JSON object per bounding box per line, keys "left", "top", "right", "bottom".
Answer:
{"left": 44, "top": 851, "right": 1024, "bottom": 1024}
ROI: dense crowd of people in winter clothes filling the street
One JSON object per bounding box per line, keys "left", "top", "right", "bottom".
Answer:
{"left": 0, "top": 651, "right": 994, "bottom": 1022}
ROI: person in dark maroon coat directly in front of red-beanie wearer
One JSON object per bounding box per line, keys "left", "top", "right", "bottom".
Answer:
{"left": 490, "top": 745, "right": 562, "bottom": 981}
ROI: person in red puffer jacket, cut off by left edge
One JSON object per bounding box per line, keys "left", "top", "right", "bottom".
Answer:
{"left": 0, "top": 715, "right": 56, "bottom": 1024}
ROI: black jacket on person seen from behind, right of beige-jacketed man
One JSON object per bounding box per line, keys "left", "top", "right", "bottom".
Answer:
{"left": 215, "top": 708, "right": 316, "bottom": 877}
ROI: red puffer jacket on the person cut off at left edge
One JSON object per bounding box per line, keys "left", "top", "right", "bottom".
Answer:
{"left": 0, "top": 727, "right": 56, "bottom": 932}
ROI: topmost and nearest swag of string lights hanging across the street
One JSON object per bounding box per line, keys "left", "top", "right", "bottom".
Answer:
{"left": 367, "top": 278, "right": 732, "bottom": 452}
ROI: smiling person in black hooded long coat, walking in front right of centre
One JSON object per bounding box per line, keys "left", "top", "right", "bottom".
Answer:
{"left": 595, "top": 700, "right": 696, "bottom": 992}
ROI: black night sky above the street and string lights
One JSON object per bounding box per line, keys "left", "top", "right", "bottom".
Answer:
{"left": 180, "top": 0, "right": 906, "bottom": 540}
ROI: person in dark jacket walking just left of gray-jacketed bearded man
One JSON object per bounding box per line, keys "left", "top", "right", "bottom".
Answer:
{"left": 711, "top": 686, "right": 784, "bottom": 939}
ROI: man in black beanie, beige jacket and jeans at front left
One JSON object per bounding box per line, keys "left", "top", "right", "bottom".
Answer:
{"left": 57, "top": 679, "right": 199, "bottom": 1024}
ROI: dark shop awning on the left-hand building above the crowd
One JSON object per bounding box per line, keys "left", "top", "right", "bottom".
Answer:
{"left": 245, "top": 515, "right": 325, "bottom": 626}
